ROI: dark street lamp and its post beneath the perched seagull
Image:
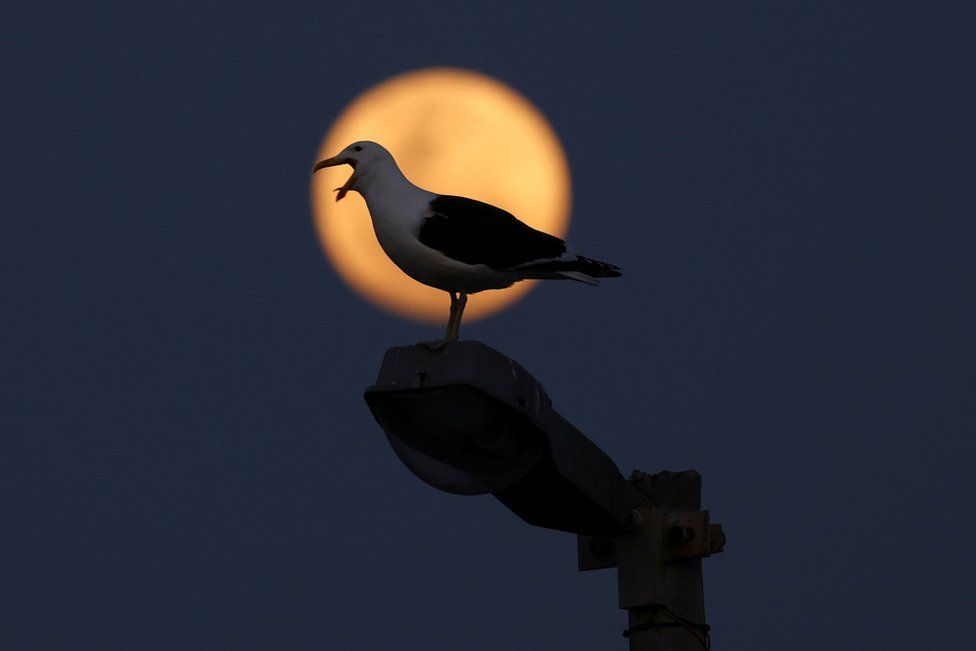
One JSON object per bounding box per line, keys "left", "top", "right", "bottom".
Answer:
{"left": 365, "top": 341, "right": 725, "bottom": 650}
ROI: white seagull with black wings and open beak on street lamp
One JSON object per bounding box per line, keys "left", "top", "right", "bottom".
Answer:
{"left": 312, "top": 140, "right": 620, "bottom": 341}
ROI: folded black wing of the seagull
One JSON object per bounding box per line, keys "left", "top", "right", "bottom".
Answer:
{"left": 419, "top": 195, "right": 566, "bottom": 269}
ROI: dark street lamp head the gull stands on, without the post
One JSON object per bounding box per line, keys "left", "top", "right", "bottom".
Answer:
{"left": 365, "top": 341, "right": 631, "bottom": 535}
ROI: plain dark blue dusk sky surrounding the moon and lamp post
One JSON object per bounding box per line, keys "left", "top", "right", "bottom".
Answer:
{"left": 0, "top": 2, "right": 976, "bottom": 650}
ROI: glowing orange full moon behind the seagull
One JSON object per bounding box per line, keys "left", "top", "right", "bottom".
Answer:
{"left": 311, "top": 68, "right": 571, "bottom": 323}
